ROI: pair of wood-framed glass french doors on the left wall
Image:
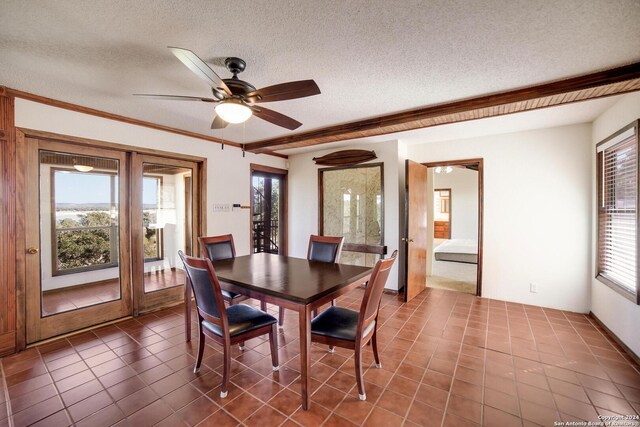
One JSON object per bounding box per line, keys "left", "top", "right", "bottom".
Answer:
{"left": 23, "top": 137, "right": 202, "bottom": 344}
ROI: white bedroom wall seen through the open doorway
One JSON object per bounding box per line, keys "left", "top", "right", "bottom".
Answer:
{"left": 429, "top": 168, "right": 478, "bottom": 240}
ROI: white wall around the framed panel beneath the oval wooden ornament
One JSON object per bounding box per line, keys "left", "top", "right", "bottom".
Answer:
{"left": 288, "top": 141, "right": 404, "bottom": 289}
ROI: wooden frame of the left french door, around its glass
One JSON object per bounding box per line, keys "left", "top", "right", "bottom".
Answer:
{"left": 16, "top": 137, "right": 132, "bottom": 348}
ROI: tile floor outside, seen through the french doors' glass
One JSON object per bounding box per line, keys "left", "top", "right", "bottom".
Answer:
{"left": 42, "top": 269, "right": 184, "bottom": 316}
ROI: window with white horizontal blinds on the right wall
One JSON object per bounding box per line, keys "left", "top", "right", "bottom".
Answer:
{"left": 596, "top": 122, "right": 640, "bottom": 303}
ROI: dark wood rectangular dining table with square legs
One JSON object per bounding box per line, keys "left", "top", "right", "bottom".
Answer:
{"left": 185, "top": 253, "right": 373, "bottom": 410}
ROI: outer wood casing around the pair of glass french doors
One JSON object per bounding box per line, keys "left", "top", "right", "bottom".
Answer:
{"left": 15, "top": 127, "right": 207, "bottom": 351}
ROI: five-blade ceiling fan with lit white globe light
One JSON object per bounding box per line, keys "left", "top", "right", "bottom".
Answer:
{"left": 134, "top": 47, "right": 320, "bottom": 130}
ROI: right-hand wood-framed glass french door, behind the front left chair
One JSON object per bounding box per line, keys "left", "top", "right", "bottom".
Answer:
{"left": 131, "top": 153, "right": 200, "bottom": 315}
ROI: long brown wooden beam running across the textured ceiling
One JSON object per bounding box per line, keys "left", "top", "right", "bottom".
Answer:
{"left": 245, "top": 62, "right": 640, "bottom": 153}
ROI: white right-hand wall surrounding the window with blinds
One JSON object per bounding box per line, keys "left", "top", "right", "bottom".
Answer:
{"left": 589, "top": 92, "right": 640, "bottom": 354}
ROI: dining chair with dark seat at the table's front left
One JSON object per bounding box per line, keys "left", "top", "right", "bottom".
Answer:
{"left": 178, "top": 251, "right": 280, "bottom": 398}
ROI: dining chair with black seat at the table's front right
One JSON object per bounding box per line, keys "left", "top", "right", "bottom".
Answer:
{"left": 311, "top": 251, "right": 398, "bottom": 400}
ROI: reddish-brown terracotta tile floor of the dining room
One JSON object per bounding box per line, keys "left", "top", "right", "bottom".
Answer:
{"left": 0, "top": 289, "right": 640, "bottom": 427}
